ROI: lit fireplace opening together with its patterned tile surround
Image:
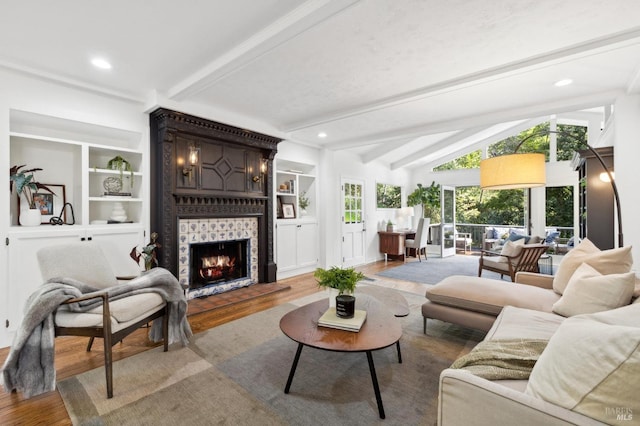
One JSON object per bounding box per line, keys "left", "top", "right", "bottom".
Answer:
{"left": 178, "top": 218, "right": 259, "bottom": 299}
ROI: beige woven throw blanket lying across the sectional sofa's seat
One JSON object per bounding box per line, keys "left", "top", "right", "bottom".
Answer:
{"left": 451, "top": 339, "right": 548, "bottom": 380}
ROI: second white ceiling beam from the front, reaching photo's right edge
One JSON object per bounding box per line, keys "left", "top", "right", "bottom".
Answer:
{"left": 282, "top": 27, "right": 640, "bottom": 133}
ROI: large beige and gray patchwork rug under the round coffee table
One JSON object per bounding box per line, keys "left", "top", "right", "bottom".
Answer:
{"left": 58, "top": 282, "right": 484, "bottom": 426}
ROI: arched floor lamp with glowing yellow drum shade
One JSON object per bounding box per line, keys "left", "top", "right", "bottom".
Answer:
{"left": 480, "top": 130, "right": 624, "bottom": 247}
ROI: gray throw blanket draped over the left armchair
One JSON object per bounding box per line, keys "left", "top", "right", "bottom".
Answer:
{"left": 2, "top": 268, "right": 192, "bottom": 398}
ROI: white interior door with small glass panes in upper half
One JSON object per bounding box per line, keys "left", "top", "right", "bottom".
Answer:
{"left": 342, "top": 179, "right": 366, "bottom": 267}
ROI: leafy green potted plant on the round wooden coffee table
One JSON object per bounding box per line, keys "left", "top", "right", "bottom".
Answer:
{"left": 313, "top": 266, "right": 364, "bottom": 318}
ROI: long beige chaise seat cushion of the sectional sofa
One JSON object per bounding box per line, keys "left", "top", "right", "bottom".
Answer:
{"left": 426, "top": 275, "right": 560, "bottom": 316}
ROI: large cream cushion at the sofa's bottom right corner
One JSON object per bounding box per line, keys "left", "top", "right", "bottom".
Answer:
{"left": 525, "top": 304, "right": 640, "bottom": 424}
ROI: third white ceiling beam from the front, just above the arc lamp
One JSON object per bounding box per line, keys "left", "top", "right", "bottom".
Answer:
{"left": 325, "top": 90, "right": 624, "bottom": 150}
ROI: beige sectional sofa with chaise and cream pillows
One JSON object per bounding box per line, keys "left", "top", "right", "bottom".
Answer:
{"left": 422, "top": 240, "right": 640, "bottom": 426}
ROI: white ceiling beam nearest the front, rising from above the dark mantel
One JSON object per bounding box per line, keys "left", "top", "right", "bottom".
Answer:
{"left": 167, "top": 0, "right": 359, "bottom": 101}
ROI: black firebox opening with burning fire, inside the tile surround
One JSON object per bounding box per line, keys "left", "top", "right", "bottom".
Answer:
{"left": 189, "top": 240, "right": 248, "bottom": 289}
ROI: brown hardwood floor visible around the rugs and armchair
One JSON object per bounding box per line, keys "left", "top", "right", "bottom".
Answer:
{"left": 0, "top": 259, "right": 425, "bottom": 425}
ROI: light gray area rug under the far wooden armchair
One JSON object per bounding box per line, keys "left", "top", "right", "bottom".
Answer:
{"left": 377, "top": 255, "right": 511, "bottom": 284}
